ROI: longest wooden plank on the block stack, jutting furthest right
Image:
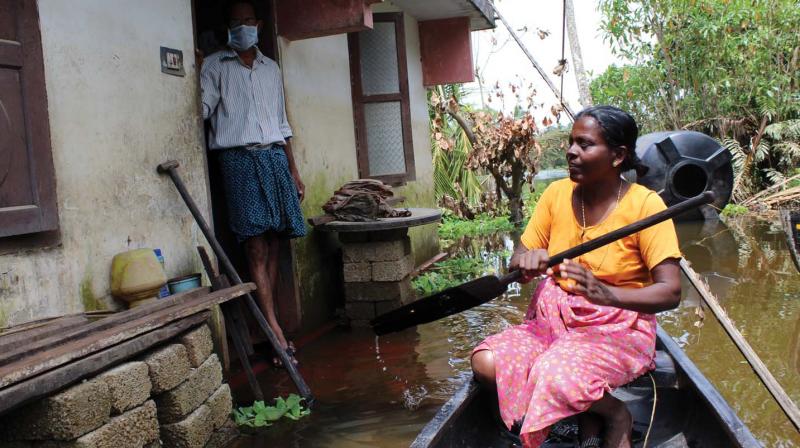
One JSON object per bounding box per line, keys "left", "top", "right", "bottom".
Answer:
{"left": 0, "top": 283, "right": 255, "bottom": 387}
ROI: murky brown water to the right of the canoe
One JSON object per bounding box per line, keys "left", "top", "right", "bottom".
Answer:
{"left": 659, "top": 219, "right": 800, "bottom": 447}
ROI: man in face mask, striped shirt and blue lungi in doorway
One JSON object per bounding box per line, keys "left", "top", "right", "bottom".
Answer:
{"left": 201, "top": 1, "right": 306, "bottom": 364}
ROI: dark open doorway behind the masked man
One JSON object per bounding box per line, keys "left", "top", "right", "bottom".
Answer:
{"left": 192, "top": 0, "right": 301, "bottom": 337}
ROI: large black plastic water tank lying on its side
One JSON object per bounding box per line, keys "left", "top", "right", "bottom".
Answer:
{"left": 636, "top": 131, "right": 733, "bottom": 220}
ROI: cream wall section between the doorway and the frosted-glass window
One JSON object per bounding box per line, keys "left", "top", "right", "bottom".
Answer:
{"left": 279, "top": 35, "right": 358, "bottom": 328}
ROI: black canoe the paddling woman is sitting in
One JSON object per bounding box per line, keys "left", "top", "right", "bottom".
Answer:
{"left": 411, "top": 328, "right": 762, "bottom": 448}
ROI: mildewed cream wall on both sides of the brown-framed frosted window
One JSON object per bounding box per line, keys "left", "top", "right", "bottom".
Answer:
{"left": 279, "top": 5, "right": 438, "bottom": 328}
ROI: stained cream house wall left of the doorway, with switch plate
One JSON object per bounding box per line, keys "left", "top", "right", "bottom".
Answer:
{"left": 0, "top": 0, "right": 208, "bottom": 327}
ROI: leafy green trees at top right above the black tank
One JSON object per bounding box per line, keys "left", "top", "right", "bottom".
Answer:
{"left": 591, "top": 0, "right": 800, "bottom": 135}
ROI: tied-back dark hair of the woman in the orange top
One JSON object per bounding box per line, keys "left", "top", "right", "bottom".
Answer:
{"left": 575, "top": 106, "right": 649, "bottom": 177}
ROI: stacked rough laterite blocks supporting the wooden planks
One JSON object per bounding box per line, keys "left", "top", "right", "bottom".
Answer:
{"left": 0, "top": 325, "right": 237, "bottom": 448}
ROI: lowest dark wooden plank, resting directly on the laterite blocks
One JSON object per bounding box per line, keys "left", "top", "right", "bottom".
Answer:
{"left": 0, "top": 311, "right": 210, "bottom": 414}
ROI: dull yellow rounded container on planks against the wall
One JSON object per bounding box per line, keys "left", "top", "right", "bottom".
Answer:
{"left": 111, "top": 249, "right": 167, "bottom": 308}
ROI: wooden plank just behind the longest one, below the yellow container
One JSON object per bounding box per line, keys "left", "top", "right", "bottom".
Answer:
{"left": 0, "top": 288, "right": 210, "bottom": 365}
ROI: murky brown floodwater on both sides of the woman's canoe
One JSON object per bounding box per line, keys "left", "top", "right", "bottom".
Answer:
{"left": 236, "top": 215, "right": 800, "bottom": 448}
